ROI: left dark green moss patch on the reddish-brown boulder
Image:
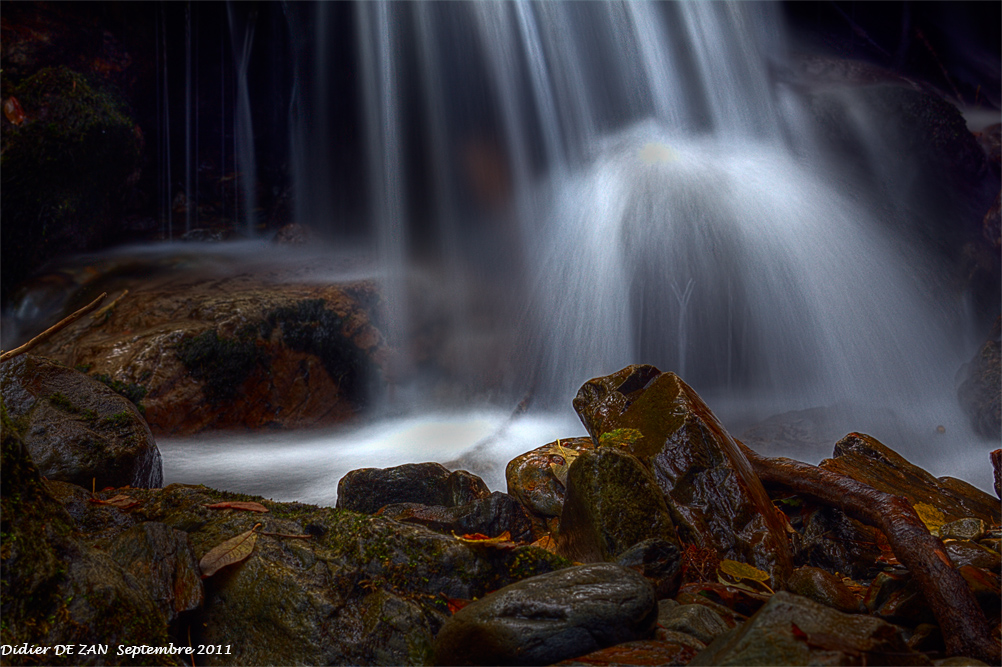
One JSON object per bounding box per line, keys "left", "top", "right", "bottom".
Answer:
{"left": 175, "top": 326, "right": 264, "bottom": 403}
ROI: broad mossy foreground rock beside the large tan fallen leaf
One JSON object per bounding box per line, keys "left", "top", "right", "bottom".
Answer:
{"left": 39, "top": 478, "right": 570, "bottom": 665}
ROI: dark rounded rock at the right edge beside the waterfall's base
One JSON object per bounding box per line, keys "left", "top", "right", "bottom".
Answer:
{"left": 957, "top": 317, "right": 1002, "bottom": 442}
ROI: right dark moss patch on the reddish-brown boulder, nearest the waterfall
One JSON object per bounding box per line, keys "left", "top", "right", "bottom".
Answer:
{"left": 262, "top": 298, "right": 374, "bottom": 406}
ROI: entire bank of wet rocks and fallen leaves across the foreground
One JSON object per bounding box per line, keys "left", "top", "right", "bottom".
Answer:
{"left": 0, "top": 357, "right": 1002, "bottom": 665}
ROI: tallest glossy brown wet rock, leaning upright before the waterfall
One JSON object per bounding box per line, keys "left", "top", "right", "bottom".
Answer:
{"left": 574, "top": 366, "right": 792, "bottom": 587}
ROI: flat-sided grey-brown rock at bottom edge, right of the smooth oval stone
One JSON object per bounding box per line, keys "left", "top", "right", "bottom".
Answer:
{"left": 689, "top": 591, "right": 932, "bottom": 665}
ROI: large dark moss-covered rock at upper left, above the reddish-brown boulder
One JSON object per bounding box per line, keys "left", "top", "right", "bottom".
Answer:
{"left": 0, "top": 66, "right": 140, "bottom": 294}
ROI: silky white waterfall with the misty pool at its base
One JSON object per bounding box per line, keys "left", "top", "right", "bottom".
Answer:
{"left": 9, "top": 2, "right": 997, "bottom": 504}
